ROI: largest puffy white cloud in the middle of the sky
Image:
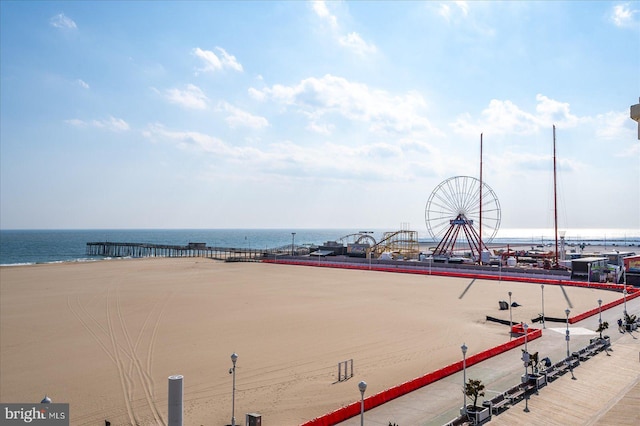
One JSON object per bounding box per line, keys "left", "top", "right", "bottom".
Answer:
{"left": 250, "top": 74, "right": 439, "bottom": 134}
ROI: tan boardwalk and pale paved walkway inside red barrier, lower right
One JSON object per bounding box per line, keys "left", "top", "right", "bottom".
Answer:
{"left": 339, "top": 292, "right": 640, "bottom": 426}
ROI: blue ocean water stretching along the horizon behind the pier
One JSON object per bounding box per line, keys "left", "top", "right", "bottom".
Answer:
{"left": 0, "top": 229, "right": 640, "bottom": 265}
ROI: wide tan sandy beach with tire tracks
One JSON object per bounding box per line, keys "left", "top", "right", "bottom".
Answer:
{"left": 0, "top": 258, "right": 620, "bottom": 426}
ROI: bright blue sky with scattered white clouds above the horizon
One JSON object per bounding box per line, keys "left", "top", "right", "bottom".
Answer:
{"left": 0, "top": 1, "right": 640, "bottom": 233}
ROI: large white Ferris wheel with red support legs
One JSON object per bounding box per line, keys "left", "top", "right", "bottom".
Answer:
{"left": 424, "top": 176, "right": 501, "bottom": 251}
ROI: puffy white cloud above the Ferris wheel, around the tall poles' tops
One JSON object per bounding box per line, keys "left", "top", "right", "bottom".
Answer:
{"left": 451, "top": 94, "right": 589, "bottom": 135}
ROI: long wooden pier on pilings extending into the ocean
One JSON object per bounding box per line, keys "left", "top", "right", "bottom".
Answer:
{"left": 87, "top": 241, "right": 274, "bottom": 262}
